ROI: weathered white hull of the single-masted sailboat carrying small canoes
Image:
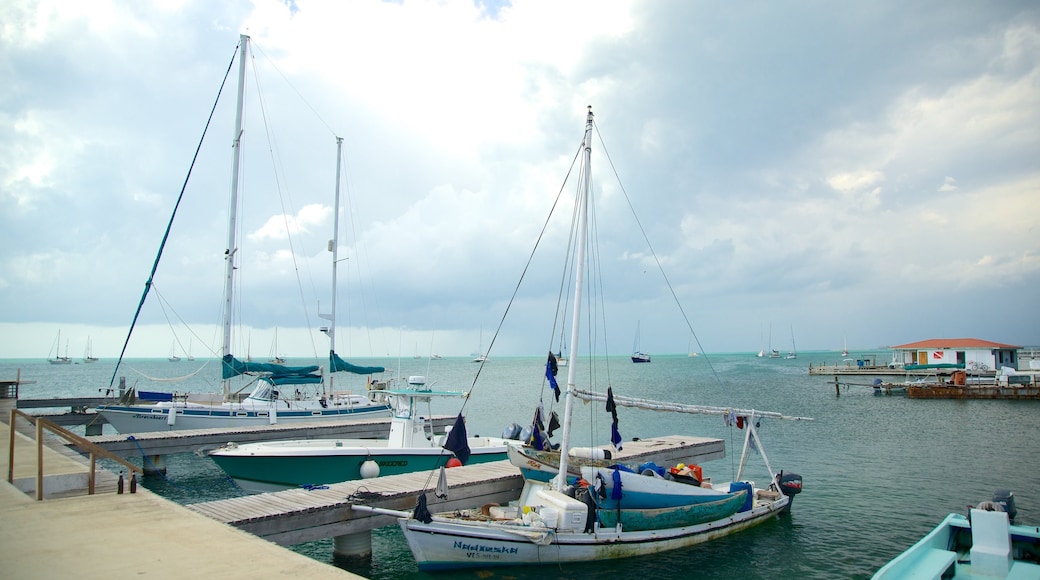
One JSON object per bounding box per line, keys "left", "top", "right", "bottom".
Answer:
{"left": 399, "top": 496, "right": 789, "bottom": 572}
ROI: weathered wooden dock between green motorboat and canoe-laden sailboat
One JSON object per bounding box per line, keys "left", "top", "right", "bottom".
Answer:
{"left": 187, "top": 436, "right": 726, "bottom": 546}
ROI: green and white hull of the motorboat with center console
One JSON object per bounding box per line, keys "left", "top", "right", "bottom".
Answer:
{"left": 209, "top": 438, "right": 505, "bottom": 494}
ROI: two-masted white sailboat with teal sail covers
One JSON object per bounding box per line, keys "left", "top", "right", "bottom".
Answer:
{"left": 97, "top": 34, "right": 390, "bottom": 433}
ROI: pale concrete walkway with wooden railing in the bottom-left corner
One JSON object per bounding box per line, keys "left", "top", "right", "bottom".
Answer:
{"left": 0, "top": 417, "right": 361, "bottom": 580}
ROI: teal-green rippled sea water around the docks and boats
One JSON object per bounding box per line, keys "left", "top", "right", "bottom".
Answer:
{"left": 0, "top": 351, "right": 1040, "bottom": 580}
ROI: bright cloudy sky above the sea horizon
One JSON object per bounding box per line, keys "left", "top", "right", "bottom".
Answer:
{"left": 0, "top": 0, "right": 1040, "bottom": 359}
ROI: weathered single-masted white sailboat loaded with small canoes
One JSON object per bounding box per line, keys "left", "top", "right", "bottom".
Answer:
{"left": 378, "top": 107, "right": 801, "bottom": 572}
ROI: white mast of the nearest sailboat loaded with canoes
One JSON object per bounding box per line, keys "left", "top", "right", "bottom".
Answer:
{"left": 555, "top": 106, "right": 593, "bottom": 490}
